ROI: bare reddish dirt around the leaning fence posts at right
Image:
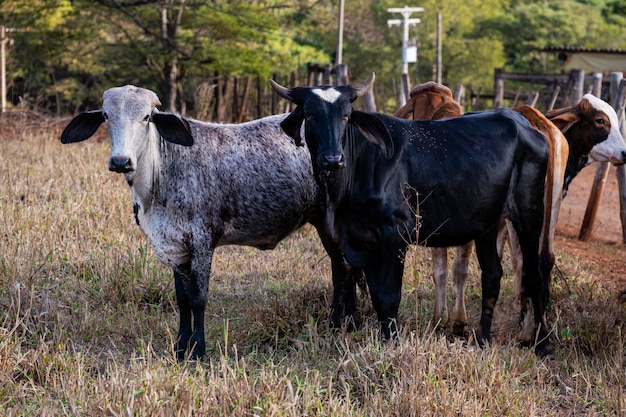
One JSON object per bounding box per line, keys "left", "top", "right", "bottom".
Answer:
{"left": 554, "top": 164, "right": 626, "bottom": 290}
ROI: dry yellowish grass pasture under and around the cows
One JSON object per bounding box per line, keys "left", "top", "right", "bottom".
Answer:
{"left": 0, "top": 113, "right": 626, "bottom": 416}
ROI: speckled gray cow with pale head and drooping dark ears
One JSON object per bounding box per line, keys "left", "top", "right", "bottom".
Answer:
{"left": 61, "top": 85, "right": 355, "bottom": 360}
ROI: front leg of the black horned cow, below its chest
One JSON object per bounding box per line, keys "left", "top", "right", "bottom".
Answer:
{"left": 363, "top": 245, "right": 406, "bottom": 340}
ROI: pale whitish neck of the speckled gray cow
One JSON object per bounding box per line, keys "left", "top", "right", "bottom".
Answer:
{"left": 126, "top": 124, "right": 163, "bottom": 208}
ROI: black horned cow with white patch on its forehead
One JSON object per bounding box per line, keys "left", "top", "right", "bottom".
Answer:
{"left": 271, "top": 75, "right": 551, "bottom": 355}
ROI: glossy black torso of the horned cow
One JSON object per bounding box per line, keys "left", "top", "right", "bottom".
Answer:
{"left": 342, "top": 109, "right": 547, "bottom": 246}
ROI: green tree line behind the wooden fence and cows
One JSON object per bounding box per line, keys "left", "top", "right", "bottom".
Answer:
{"left": 0, "top": 0, "right": 626, "bottom": 121}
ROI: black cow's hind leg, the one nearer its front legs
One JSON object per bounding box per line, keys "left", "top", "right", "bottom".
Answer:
{"left": 474, "top": 227, "right": 502, "bottom": 345}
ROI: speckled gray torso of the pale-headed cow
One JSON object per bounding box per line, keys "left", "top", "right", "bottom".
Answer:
{"left": 138, "top": 115, "right": 320, "bottom": 260}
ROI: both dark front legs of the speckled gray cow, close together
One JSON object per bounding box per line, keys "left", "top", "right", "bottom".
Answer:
{"left": 174, "top": 251, "right": 213, "bottom": 361}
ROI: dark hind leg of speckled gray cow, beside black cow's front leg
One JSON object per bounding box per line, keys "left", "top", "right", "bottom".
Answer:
{"left": 315, "top": 225, "right": 363, "bottom": 330}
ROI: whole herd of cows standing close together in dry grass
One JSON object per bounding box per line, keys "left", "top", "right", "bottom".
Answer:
{"left": 61, "top": 74, "right": 626, "bottom": 361}
